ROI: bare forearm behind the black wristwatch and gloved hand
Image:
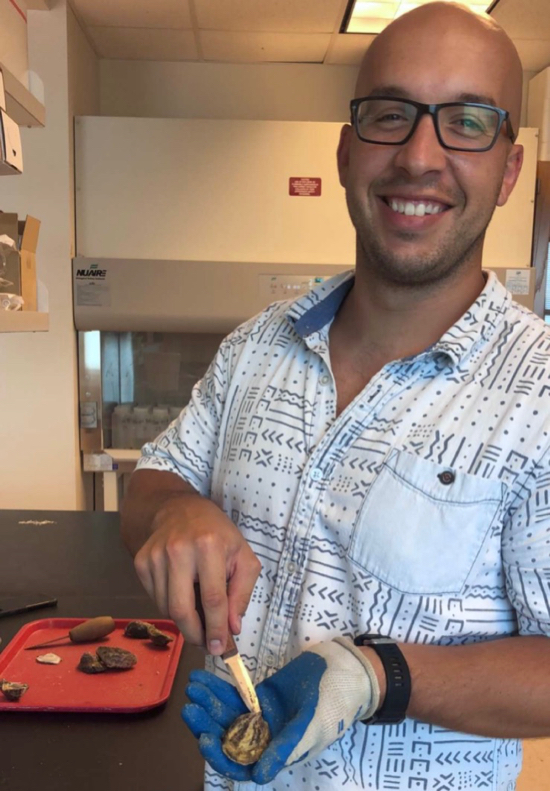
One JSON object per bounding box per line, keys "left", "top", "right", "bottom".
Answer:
{"left": 363, "top": 637, "right": 550, "bottom": 738}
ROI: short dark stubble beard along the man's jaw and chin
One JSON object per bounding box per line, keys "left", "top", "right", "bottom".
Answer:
{"left": 347, "top": 194, "right": 496, "bottom": 288}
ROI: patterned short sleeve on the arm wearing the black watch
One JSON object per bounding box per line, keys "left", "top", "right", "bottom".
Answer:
{"left": 502, "top": 450, "right": 550, "bottom": 636}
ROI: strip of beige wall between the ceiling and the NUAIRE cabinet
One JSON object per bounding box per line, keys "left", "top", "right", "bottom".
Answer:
{"left": 101, "top": 60, "right": 357, "bottom": 121}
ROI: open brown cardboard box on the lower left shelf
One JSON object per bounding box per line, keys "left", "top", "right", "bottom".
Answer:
{"left": 0, "top": 212, "right": 40, "bottom": 311}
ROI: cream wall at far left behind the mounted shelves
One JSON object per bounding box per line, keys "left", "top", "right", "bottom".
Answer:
{"left": 0, "top": 0, "right": 98, "bottom": 509}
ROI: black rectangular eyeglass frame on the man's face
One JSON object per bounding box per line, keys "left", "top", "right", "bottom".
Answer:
{"left": 350, "top": 96, "right": 517, "bottom": 154}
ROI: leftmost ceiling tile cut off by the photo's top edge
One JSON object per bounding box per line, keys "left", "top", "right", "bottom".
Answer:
{"left": 71, "top": 0, "right": 192, "bottom": 30}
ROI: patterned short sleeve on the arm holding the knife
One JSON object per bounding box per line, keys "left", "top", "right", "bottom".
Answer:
{"left": 137, "top": 339, "right": 233, "bottom": 497}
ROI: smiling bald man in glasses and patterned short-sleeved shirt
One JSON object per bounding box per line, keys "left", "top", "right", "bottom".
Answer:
{"left": 123, "top": 3, "right": 550, "bottom": 791}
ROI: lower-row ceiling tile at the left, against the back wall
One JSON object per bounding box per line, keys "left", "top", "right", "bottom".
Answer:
{"left": 88, "top": 26, "right": 198, "bottom": 61}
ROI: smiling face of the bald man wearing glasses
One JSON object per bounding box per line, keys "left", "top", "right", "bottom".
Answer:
{"left": 338, "top": 20, "right": 521, "bottom": 285}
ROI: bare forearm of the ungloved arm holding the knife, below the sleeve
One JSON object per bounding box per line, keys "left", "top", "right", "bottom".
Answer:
{"left": 121, "top": 470, "right": 200, "bottom": 555}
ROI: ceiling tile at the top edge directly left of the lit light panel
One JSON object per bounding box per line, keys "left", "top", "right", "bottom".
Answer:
{"left": 196, "top": 0, "right": 343, "bottom": 33}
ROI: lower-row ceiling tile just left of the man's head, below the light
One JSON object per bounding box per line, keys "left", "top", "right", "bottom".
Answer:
{"left": 199, "top": 30, "right": 330, "bottom": 63}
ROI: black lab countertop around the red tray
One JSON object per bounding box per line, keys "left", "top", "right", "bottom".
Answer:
{"left": 0, "top": 511, "right": 203, "bottom": 791}
